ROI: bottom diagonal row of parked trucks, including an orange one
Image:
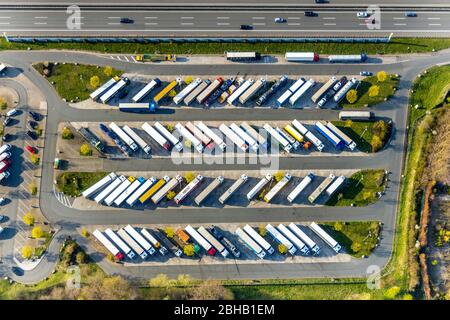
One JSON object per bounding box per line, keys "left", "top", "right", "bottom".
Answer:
{"left": 93, "top": 222, "right": 341, "bottom": 261}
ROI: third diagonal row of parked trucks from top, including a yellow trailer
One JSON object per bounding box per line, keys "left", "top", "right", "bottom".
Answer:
{"left": 82, "top": 168, "right": 345, "bottom": 207}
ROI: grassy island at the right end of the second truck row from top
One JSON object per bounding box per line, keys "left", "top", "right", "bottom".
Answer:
{"left": 331, "top": 120, "right": 391, "bottom": 152}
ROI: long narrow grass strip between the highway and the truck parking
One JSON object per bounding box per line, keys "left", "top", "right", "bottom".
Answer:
{"left": 0, "top": 38, "right": 450, "bottom": 54}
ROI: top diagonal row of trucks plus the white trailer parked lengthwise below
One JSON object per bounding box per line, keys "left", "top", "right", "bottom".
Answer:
{"left": 90, "top": 70, "right": 357, "bottom": 112}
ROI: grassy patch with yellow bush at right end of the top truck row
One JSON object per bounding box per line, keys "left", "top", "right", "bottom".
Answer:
{"left": 339, "top": 75, "right": 399, "bottom": 108}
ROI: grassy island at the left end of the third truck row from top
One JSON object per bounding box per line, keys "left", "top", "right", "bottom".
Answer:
{"left": 56, "top": 172, "right": 107, "bottom": 197}
